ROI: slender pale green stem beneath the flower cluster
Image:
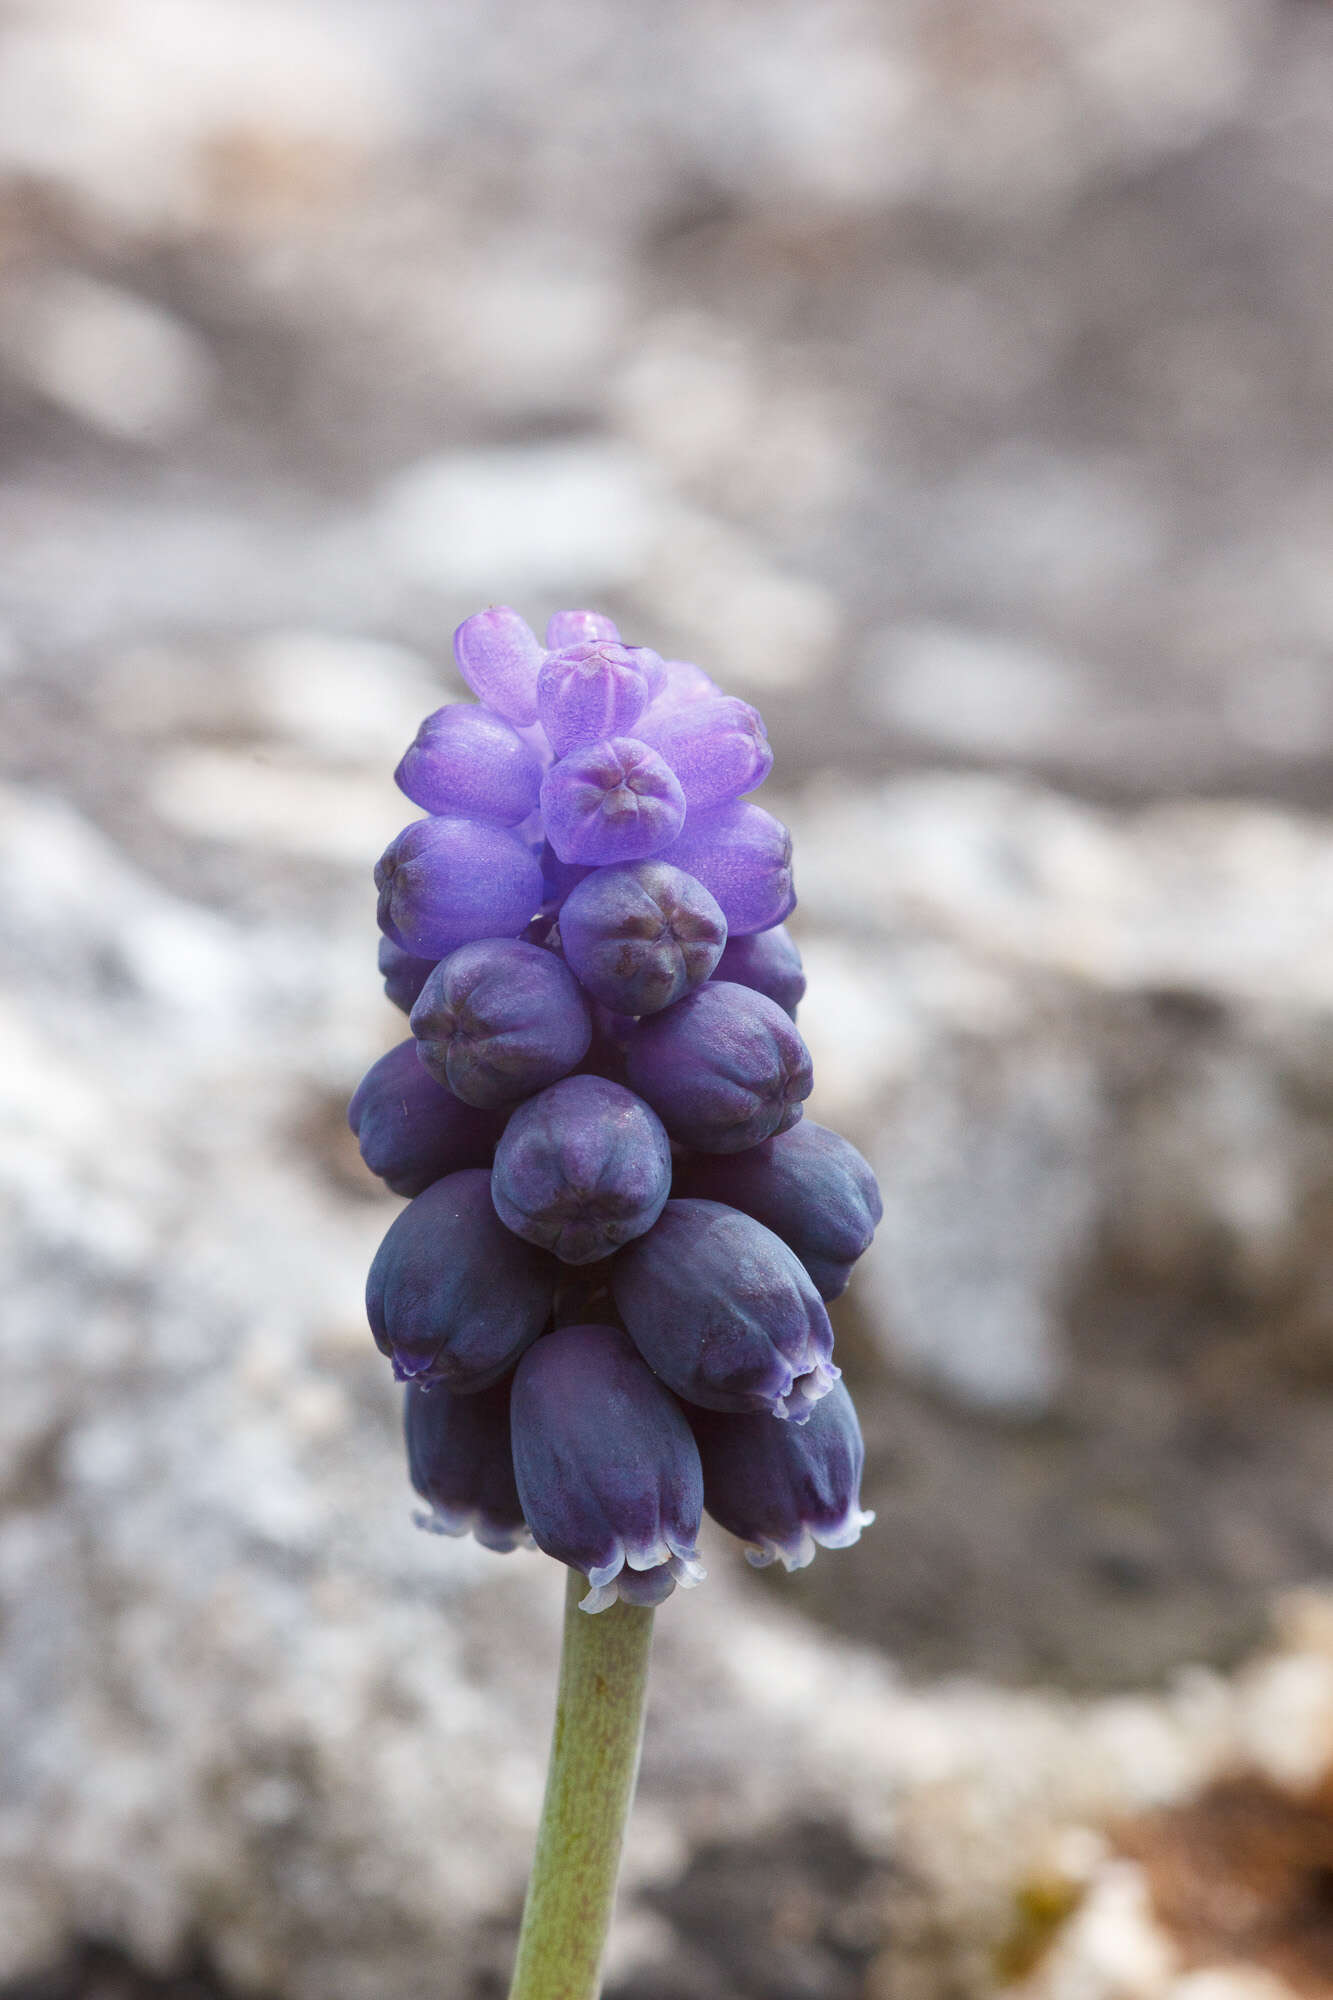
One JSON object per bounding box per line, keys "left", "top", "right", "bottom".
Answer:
{"left": 508, "top": 1570, "right": 652, "bottom": 2000}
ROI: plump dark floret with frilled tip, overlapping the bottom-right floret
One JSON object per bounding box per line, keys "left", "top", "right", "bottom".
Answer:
{"left": 610, "top": 1200, "right": 839, "bottom": 1424}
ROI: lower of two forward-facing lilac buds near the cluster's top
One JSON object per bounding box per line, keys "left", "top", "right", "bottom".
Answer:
{"left": 542, "top": 736, "right": 684, "bottom": 860}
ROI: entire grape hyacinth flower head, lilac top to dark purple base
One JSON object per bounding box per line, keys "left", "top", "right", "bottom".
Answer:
{"left": 350, "top": 606, "right": 881, "bottom": 1610}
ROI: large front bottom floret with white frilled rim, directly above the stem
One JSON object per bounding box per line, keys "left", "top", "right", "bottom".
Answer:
{"left": 510, "top": 1326, "right": 703, "bottom": 1612}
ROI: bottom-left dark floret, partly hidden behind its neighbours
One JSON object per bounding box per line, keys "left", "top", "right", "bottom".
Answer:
{"left": 402, "top": 1380, "right": 532, "bottom": 1554}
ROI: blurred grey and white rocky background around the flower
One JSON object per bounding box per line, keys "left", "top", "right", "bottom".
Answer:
{"left": 0, "top": 0, "right": 1333, "bottom": 2000}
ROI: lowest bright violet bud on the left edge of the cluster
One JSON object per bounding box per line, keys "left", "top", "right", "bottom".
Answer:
{"left": 374, "top": 818, "right": 542, "bottom": 958}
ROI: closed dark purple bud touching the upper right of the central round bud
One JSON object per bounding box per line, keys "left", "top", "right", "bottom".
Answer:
{"left": 624, "top": 980, "right": 813, "bottom": 1154}
